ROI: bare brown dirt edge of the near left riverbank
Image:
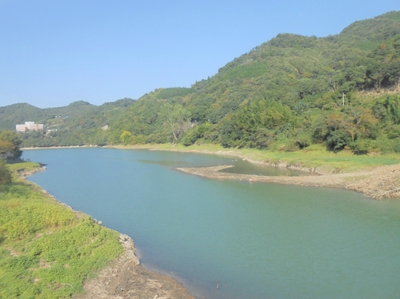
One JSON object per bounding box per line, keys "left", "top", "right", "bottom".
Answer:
{"left": 14, "top": 165, "right": 194, "bottom": 299}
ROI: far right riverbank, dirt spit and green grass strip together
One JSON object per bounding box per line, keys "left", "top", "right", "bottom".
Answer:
{"left": 111, "top": 146, "right": 400, "bottom": 199}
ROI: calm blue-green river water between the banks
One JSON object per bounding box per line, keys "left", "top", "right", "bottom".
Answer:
{"left": 23, "top": 148, "right": 400, "bottom": 299}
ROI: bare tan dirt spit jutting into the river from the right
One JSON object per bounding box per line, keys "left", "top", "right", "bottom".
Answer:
{"left": 178, "top": 164, "right": 400, "bottom": 199}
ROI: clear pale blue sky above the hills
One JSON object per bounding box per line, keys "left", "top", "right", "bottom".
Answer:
{"left": 0, "top": 0, "right": 400, "bottom": 108}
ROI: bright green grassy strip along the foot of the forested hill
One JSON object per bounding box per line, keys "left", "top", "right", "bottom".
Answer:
{"left": 120, "top": 144, "right": 400, "bottom": 172}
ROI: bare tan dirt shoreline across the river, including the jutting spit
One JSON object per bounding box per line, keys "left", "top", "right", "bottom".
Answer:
{"left": 22, "top": 144, "right": 400, "bottom": 199}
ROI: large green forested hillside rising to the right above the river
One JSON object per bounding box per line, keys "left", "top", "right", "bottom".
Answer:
{"left": 0, "top": 11, "right": 400, "bottom": 154}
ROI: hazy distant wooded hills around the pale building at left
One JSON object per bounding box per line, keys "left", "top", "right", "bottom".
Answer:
{"left": 0, "top": 99, "right": 133, "bottom": 147}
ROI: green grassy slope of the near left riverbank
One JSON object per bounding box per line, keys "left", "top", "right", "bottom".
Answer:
{"left": 0, "top": 162, "right": 122, "bottom": 299}
